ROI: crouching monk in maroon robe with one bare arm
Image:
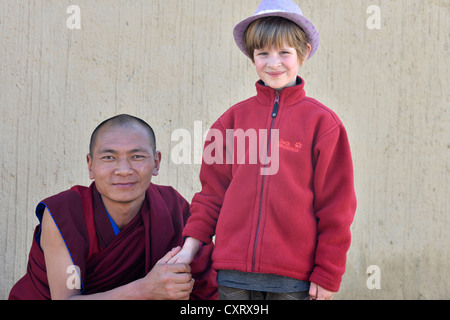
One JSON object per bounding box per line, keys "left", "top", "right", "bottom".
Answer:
{"left": 9, "top": 115, "right": 217, "bottom": 300}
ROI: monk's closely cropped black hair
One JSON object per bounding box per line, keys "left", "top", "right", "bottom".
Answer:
{"left": 89, "top": 114, "right": 156, "bottom": 156}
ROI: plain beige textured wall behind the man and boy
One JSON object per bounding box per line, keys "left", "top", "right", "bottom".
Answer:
{"left": 0, "top": 0, "right": 450, "bottom": 299}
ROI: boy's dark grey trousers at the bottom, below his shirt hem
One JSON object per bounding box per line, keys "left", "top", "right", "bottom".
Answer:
{"left": 219, "top": 286, "right": 309, "bottom": 300}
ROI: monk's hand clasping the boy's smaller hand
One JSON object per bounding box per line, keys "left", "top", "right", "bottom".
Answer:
{"left": 140, "top": 247, "right": 194, "bottom": 300}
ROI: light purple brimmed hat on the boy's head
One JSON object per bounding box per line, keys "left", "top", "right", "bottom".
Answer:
{"left": 233, "top": 0, "right": 319, "bottom": 59}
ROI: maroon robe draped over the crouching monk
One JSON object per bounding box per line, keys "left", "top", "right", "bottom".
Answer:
{"left": 9, "top": 183, "right": 217, "bottom": 300}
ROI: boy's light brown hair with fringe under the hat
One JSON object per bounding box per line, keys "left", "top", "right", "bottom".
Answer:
{"left": 244, "top": 17, "right": 308, "bottom": 62}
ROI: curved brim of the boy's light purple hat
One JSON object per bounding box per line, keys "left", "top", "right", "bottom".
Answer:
{"left": 233, "top": 11, "right": 320, "bottom": 59}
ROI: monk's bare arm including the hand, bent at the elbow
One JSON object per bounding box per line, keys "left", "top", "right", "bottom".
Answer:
{"left": 41, "top": 209, "right": 194, "bottom": 300}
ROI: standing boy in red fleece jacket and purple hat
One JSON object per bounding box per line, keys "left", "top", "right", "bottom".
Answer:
{"left": 170, "top": 0, "right": 356, "bottom": 299}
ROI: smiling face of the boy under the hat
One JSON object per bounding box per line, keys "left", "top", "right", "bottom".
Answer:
{"left": 253, "top": 44, "right": 306, "bottom": 90}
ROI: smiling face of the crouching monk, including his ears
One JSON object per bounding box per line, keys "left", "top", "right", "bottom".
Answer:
{"left": 87, "top": 125, "right": 161, "bottom": 207}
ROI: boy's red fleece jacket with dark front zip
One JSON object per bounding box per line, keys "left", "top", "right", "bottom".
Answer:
{"left": 183, "top": 78, "right": 356, "bottom": 292}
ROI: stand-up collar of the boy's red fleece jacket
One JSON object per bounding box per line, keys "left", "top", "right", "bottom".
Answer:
{"left": 255, "top": 76, "right": 306, "bottom": 107}
